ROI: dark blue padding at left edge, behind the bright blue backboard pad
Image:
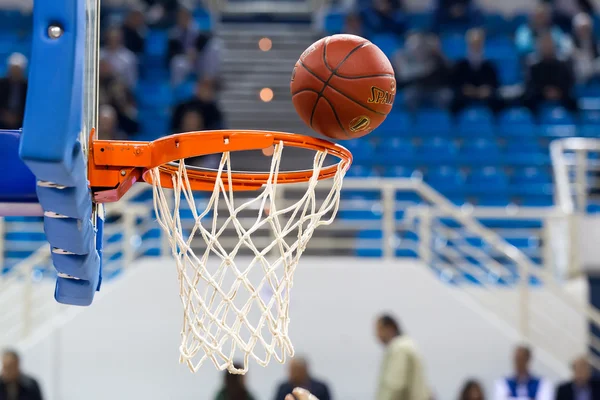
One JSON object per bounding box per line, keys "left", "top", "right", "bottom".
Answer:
{"left": 0, "top": 130, "right": 37, "bottom": 202}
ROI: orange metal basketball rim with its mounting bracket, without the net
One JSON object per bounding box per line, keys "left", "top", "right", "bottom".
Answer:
{"left": 88, "top": 130, "right": 352, "bottom": 202}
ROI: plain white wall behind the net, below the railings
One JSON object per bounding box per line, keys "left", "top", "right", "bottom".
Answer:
{"left": 15, "top": 258, "right": 585, "bottom": 400}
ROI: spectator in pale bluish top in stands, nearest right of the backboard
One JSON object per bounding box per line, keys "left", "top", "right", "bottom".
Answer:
{"left": 100, "top": 26, "right": 138, "bottom": 88}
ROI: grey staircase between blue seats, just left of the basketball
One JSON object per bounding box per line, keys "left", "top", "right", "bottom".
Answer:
{"left": 218, "top": 23, "right": 316, "bottom": 134}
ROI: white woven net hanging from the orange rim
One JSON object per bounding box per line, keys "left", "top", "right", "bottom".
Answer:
{"left": 151, "top": 143, "right": 347, "bottom": 374}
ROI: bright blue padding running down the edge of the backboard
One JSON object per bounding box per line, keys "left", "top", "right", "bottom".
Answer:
{"left": 19, "top": 0, "right": 102, "bottom": 305}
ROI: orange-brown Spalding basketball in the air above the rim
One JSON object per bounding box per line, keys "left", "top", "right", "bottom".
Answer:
{"left": 290, "top": 35, "right": 396, "bottom": 139}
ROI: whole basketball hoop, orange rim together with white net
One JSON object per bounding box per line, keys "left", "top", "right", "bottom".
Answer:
{"left": 89, "top": 131, "right": 352, "bottom": 374}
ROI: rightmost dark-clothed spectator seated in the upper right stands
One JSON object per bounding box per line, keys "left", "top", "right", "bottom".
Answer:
{"left": 525, "top": 32, "right": 577, "bottom": 111}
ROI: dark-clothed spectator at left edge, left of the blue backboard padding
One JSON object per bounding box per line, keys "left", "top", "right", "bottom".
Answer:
{"left": 0, "top": 53, "right": 27, "bottom": 129}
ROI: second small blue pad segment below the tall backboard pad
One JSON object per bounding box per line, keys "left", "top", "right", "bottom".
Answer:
{"left": 44, "top": 217, "right": 96, "bottom": 255}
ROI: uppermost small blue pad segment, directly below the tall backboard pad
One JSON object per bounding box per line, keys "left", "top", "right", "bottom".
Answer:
{"left": 37, "top": 180, "right": 92, "bottom": 219}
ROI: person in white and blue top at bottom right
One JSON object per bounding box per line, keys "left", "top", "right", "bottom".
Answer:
{"left": 494, "top": 346, "right": 554, "bottom": 400}
